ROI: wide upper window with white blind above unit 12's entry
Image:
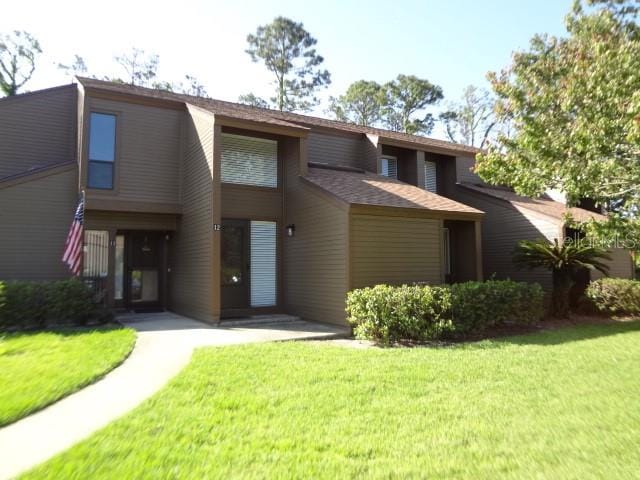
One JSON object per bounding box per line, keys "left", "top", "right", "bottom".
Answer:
{"left": 221, "top": 133, "right": 278, "bottom": 188}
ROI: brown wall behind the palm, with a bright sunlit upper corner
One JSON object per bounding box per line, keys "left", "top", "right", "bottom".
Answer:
{"left": 453, "top": 187, "right": 561, "bottom": 290}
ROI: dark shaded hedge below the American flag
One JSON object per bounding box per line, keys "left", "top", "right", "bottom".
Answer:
{"left": 0, "top": 279, "right": 109, "bottom": 329}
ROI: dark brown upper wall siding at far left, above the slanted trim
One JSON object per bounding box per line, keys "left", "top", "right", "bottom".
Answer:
{"left": 0, "top": 85, "right": 77, "bottom": 178}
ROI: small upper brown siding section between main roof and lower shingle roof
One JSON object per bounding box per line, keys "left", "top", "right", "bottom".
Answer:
{"left": 307, "top": 132, "right": 370, "bottom": 169}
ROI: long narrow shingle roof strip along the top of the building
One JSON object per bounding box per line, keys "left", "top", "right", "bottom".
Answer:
{"left": 76, "top": 77, "right": 480, "bottom": 155}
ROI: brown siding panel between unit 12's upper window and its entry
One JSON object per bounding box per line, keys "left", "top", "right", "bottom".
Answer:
{"left": 222, "top": 184, "right": 282, "bottom": 220}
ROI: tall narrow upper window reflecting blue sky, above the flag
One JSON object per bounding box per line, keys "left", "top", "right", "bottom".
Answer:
{"left": 87, "top": 112, "right": 116, "bottom": 189}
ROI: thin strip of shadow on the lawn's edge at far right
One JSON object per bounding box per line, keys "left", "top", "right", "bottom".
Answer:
{"left": 483, "top": 320, "right": 640, "bottom": 347}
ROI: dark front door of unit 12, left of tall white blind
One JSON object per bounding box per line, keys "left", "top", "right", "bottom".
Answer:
{"left": 220, "top": 220, "right": 250, "bottom": 310}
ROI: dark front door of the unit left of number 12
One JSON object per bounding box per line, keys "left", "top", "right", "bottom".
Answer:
{"left": 126, "top": 232, "right": 164, "bottom": 310}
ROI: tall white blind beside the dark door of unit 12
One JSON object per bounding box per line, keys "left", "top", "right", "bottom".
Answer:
{"left": 250, "top": 221, "right": 276, "bottom": 307}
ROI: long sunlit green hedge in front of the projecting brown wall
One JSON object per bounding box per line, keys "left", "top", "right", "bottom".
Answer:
{"left": 347, "top": 280, "right": 544, "bottom": 343}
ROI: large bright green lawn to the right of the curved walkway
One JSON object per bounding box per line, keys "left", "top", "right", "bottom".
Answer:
{"left": 21, "top": 322, "right": 640, "bottom": 479}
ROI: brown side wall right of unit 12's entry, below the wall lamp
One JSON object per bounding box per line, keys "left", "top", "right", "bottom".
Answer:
{"left": 283, "top": 139, "right": 348, "bottom": 324}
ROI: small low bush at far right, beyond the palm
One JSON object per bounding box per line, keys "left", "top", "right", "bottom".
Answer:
{"left": 585, "top": 278, "right": 640, "bottom": 315}
